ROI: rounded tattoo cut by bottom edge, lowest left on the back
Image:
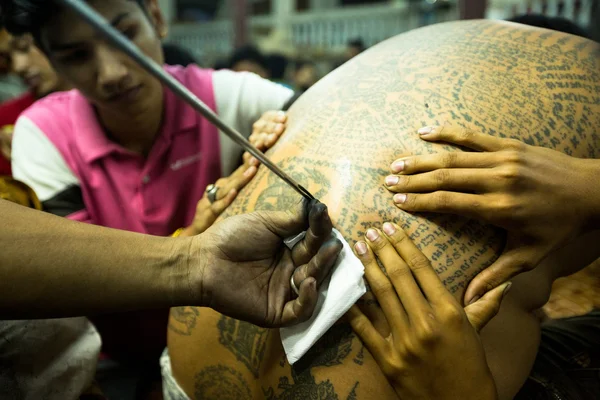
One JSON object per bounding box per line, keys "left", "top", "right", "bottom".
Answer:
{"left": 194, "top": 365, "right": 252, "bottom": 400}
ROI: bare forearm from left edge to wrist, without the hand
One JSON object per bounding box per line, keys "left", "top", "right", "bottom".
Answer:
{"left": 0, "top": 200, "right": 200, "bottom": 319}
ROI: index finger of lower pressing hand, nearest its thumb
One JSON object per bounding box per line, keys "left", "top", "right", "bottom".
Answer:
{"left": 383, "top": 222, "right": 452, "bottom": 309}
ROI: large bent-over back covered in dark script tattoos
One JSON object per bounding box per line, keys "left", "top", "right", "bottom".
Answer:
{"left": 169, "top": 21, "right": 600, "bottom": 399}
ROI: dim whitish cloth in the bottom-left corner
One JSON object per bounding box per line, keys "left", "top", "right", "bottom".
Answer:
{"left": 0, "top": 317, "right": 101, "bottom": 400}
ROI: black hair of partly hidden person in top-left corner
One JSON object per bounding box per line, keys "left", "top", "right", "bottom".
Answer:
{"left": 0, "top": 0, "right": 145, "bottom": 37}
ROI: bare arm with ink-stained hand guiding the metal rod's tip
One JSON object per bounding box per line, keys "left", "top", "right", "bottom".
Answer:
{"left": 0, "top": 200, "right": 342, "bottom": 327}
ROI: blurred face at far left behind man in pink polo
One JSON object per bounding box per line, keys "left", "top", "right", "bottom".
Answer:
{"left": 10, "top": 35, "right": 64, "bottom": 97}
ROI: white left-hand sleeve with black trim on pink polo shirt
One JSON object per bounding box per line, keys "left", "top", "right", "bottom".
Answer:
{"left": 12, "top": 117, "right": 89, "bottom": 219}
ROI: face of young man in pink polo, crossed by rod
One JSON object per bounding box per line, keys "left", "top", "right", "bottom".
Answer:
{"left": 40, "top": 0, "right": 165, "bottom": 116}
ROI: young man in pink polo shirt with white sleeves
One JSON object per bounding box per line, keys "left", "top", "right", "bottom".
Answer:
{"left": 3, "top": 0, "right": 293, "bottom": 390}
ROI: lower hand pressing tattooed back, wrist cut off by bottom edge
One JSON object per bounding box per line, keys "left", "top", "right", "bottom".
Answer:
{"left": 348, "top": 223, "right": 510, "bottom": 400}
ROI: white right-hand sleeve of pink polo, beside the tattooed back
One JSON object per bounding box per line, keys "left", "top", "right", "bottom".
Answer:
{"left": 213, "top": 70, "right": 294, "bottom": 176}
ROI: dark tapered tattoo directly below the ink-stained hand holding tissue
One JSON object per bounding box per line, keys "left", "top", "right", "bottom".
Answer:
{"left": 217, "top": 315, "right": 269, "bottom": 378}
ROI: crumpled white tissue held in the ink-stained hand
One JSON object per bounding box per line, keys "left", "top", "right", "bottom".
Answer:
{"left": 279, "top": 229, "right": 367, "bottom": 365}
